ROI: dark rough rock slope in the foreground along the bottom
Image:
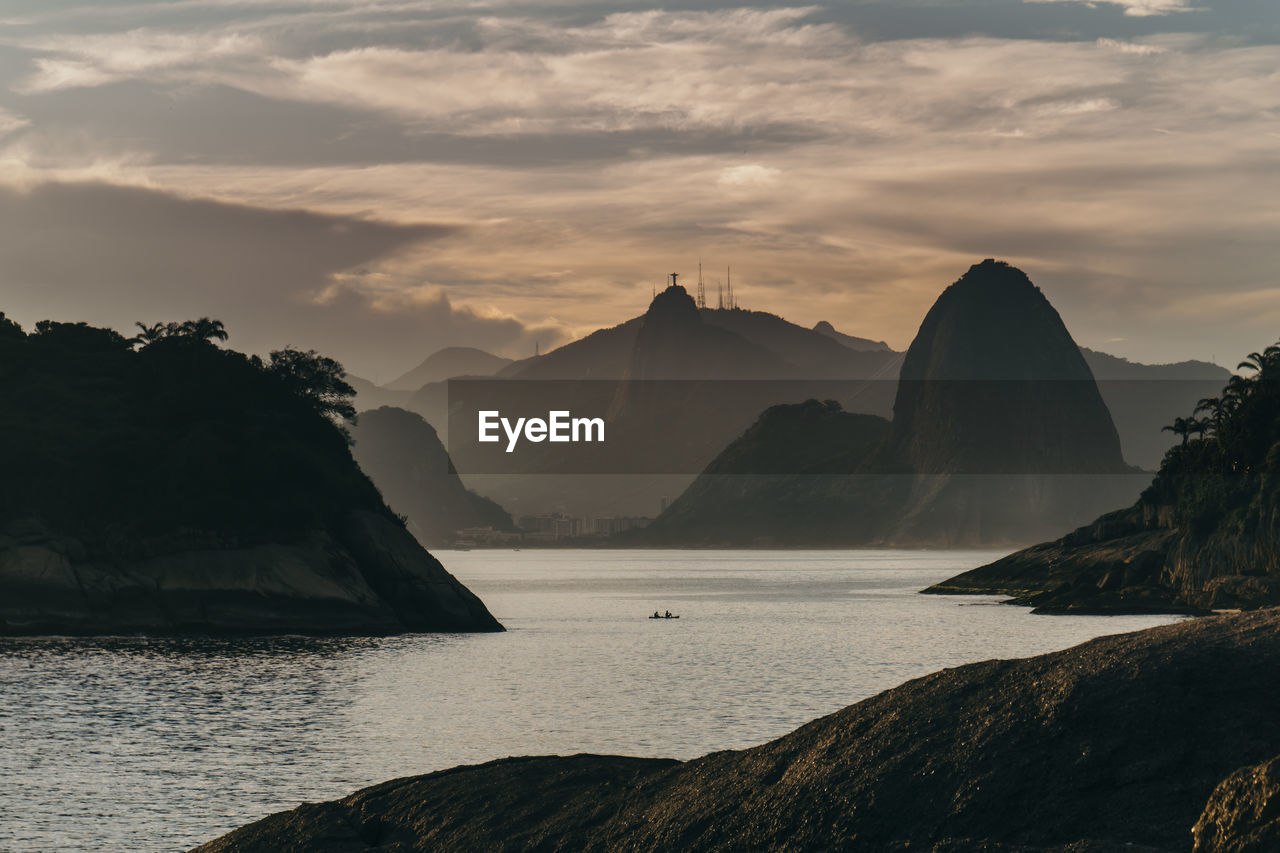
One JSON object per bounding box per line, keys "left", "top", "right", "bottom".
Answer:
{"left": 197, "top": 610, "right": 1280, "bottom": 853}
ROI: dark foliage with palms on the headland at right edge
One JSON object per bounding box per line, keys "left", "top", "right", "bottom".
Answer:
{"left": 1143, "top": 345, "right": 1280, "bottom": 534}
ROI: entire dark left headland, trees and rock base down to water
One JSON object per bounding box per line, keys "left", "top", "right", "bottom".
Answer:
{"left": 0, "top": 315, "right": 502, "bottom": 635}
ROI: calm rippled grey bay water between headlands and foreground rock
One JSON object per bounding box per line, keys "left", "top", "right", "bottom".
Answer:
{"left": 0, "top": 551, "right": 1169, "bottom": 852}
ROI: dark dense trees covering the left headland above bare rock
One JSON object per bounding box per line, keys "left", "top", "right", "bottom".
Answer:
{"left": 0, "top": 314, "right": 388, "bottom": 543}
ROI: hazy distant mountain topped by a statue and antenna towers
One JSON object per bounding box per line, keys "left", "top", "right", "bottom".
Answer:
{"left": 450, "top": 286, "right": 899, "bottom": 516}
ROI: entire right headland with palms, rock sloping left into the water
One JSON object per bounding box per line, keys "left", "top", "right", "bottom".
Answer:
{"left": 928, "top": 345, "right": 1280, "bottom": 612}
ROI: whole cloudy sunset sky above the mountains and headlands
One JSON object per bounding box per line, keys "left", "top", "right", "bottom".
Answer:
{"left": 0, "top": 0, "right": 1280, "bottom": 380}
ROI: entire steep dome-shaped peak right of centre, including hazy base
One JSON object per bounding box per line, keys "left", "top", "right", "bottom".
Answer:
{"left": 892, "top": 260, "right": 1146, "bottom": 544}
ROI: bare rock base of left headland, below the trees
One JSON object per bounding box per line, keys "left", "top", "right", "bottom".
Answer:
{"left": 0, "top": 511, "right": 502, "bottom": 635}
